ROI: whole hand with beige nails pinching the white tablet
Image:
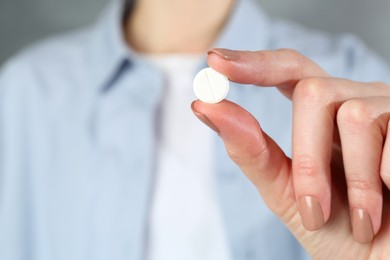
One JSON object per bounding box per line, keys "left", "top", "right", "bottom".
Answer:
{"left": 192, "top": 49, "right": 390, "bottom": 259}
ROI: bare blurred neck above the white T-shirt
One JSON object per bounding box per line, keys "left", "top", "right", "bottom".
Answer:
{"left": 125, "top": 0, "right": 235, "bottom": 54}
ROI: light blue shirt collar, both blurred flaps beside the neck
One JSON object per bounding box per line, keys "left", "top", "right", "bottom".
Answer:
{"left": 88, "top": 0, "right": 269, "bottom": 90}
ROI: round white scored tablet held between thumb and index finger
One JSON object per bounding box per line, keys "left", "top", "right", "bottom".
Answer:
{"left": 194, "top": 68, "right": 229, "bottom": 103}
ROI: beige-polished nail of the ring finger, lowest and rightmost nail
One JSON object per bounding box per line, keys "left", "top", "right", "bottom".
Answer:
{"left": 352, "top": 209, "right": 374, "bottom": 243}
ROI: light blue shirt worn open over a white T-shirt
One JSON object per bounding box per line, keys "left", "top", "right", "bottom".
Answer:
{"left": 0, "top": 0, "right": 390, "bottom": 260}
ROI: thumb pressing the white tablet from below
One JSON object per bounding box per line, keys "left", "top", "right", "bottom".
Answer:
{"left": 191, "top": 100, "right": 299, "bottom": 219}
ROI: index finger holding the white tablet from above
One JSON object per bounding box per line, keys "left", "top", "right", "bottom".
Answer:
{"left": 207, "top": 48, "right": 329, "bottom": 99}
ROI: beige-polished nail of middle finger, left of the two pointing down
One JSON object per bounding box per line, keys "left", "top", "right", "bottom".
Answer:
{"left": 299, "top": 196, "right": 325, "bottom": 231}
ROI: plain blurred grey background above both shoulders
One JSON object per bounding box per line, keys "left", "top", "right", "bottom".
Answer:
{"left": 0, "top": 0, "right": 390, "bottom": 64}
